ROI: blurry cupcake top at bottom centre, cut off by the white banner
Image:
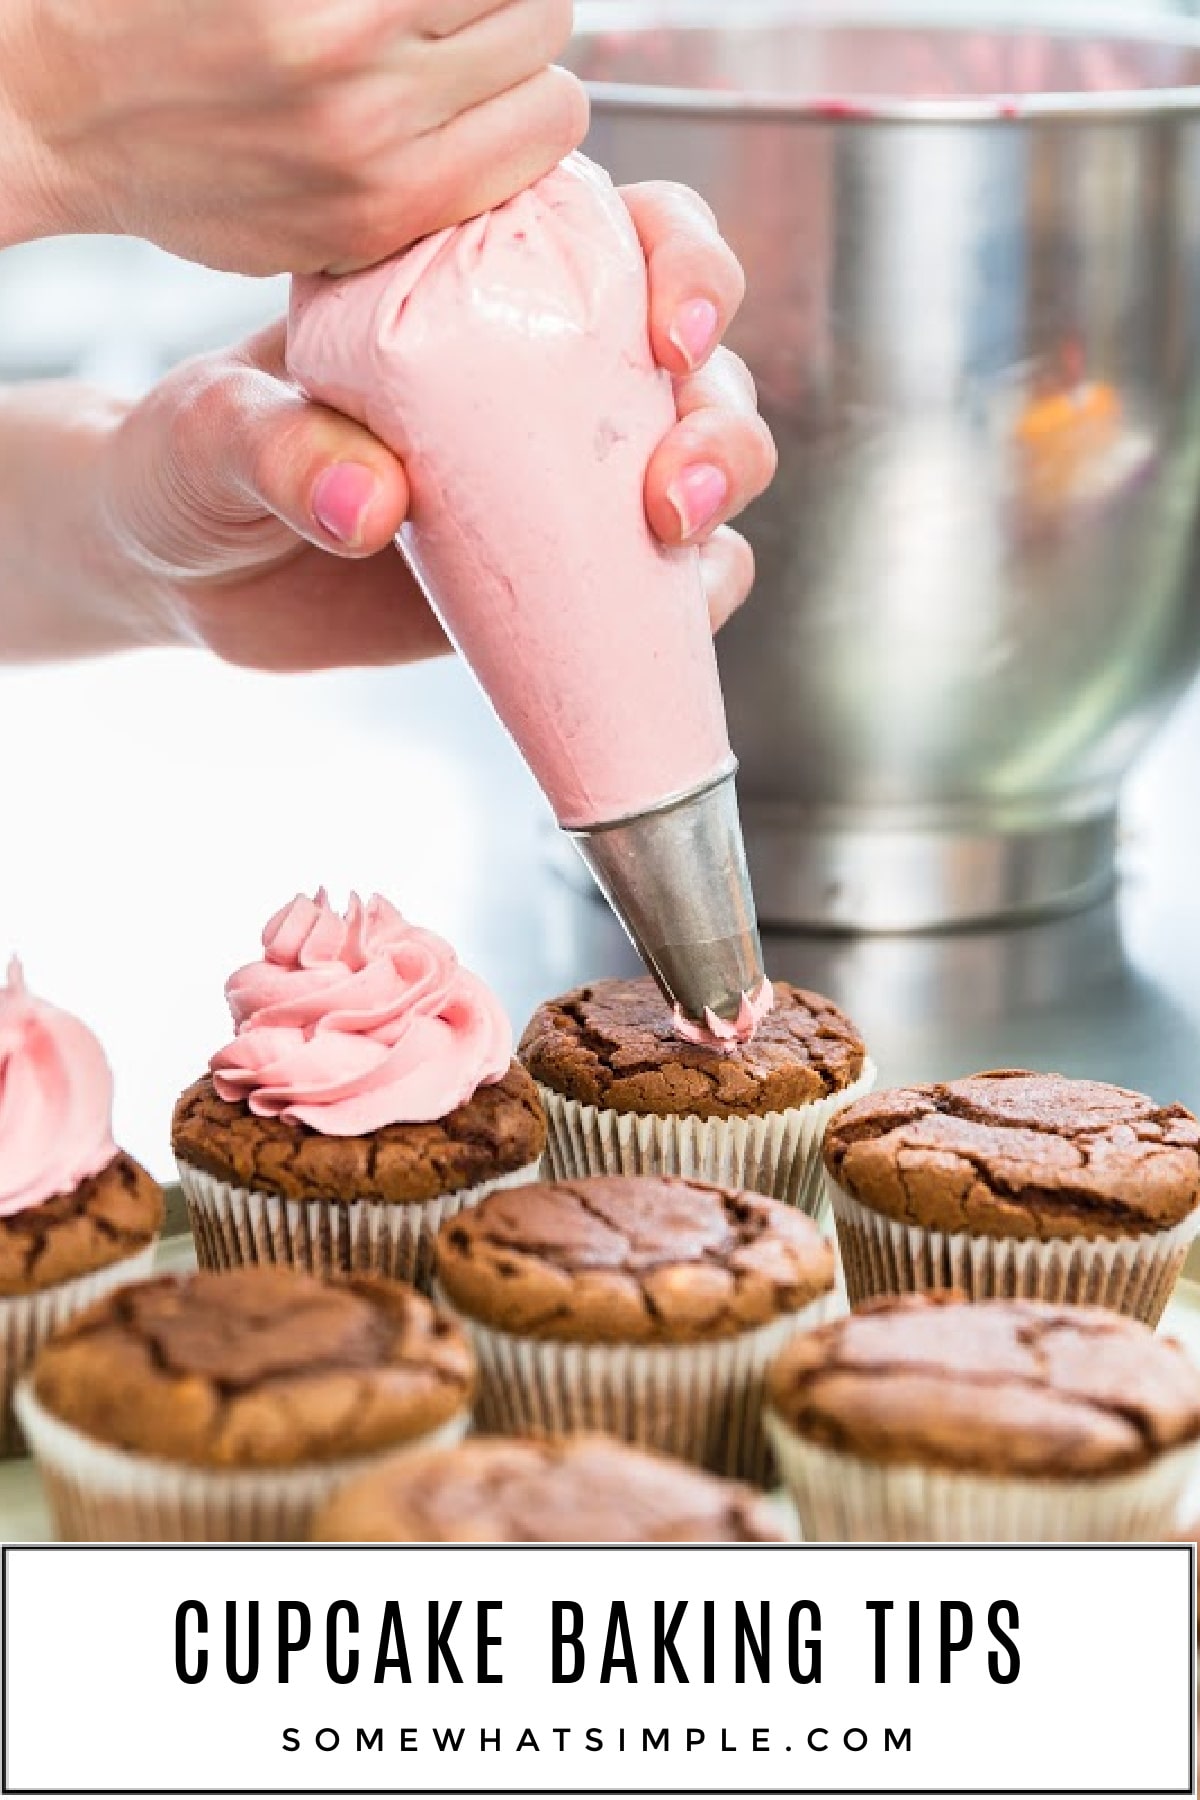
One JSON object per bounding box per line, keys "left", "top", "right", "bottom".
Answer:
{"left": 311, "top": 1435, "right": 784, "bottom": 1544}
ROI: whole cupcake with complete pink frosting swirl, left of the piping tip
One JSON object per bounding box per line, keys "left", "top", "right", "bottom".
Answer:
{"left": 171, "top": 891, "right": 545, "bottom": 1287}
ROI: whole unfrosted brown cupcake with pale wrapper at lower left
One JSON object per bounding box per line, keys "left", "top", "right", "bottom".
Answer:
{"left": 16, "top": 1269, "right": 473, "bottom": 1541}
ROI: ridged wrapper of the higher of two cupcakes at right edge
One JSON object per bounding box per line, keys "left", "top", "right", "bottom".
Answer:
{"left": 826, "top": 1177, "right": 1200, "bottom": 1325}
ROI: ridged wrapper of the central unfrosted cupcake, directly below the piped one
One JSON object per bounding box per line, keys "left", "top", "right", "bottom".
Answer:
{"left": 437, "top": 1292, "right": 828, "bottom": 1487}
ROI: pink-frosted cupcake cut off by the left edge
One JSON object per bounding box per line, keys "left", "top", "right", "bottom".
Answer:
{"left": 0, "top": 961, "right": 162, "bottom": 1456}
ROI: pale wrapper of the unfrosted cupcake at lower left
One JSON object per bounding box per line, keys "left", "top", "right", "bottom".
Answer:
{"left": 16, "top": 1381, "right": 470, "bottom": 1543}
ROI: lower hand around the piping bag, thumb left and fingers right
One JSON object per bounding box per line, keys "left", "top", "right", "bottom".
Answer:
{"left": 86, "top": 184, "right": 775, "bottom": 670}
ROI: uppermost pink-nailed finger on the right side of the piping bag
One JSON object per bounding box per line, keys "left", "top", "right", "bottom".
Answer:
{"left": 621, "top": 182, "right": 747, "bottom": 376}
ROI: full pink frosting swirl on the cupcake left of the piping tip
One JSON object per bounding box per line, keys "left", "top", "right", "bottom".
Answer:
{"left": 210, "top": 889, "right": 513, "bottom": 1138}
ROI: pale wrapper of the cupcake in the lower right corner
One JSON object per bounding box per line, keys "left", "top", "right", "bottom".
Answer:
{"left": 766, "top": 1409, "right": 1196, "bottom": 1544}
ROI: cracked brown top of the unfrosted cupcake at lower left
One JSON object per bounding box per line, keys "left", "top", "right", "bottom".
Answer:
{"left": 34, "top": 1267, "right": 473, "bottom": 1469}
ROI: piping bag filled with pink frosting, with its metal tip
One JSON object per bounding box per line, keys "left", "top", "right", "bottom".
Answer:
{"left": 288, "top": 155, "right": 770, "bottom": 1040}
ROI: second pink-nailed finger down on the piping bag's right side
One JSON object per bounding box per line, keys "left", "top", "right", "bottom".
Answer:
{"left": 646, "top": 349, "right": 777, "bottom": 544}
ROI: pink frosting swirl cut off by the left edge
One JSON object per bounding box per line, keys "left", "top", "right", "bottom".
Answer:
{"left": 0, "top": 958, "right": 117, "bottom": 1219}
